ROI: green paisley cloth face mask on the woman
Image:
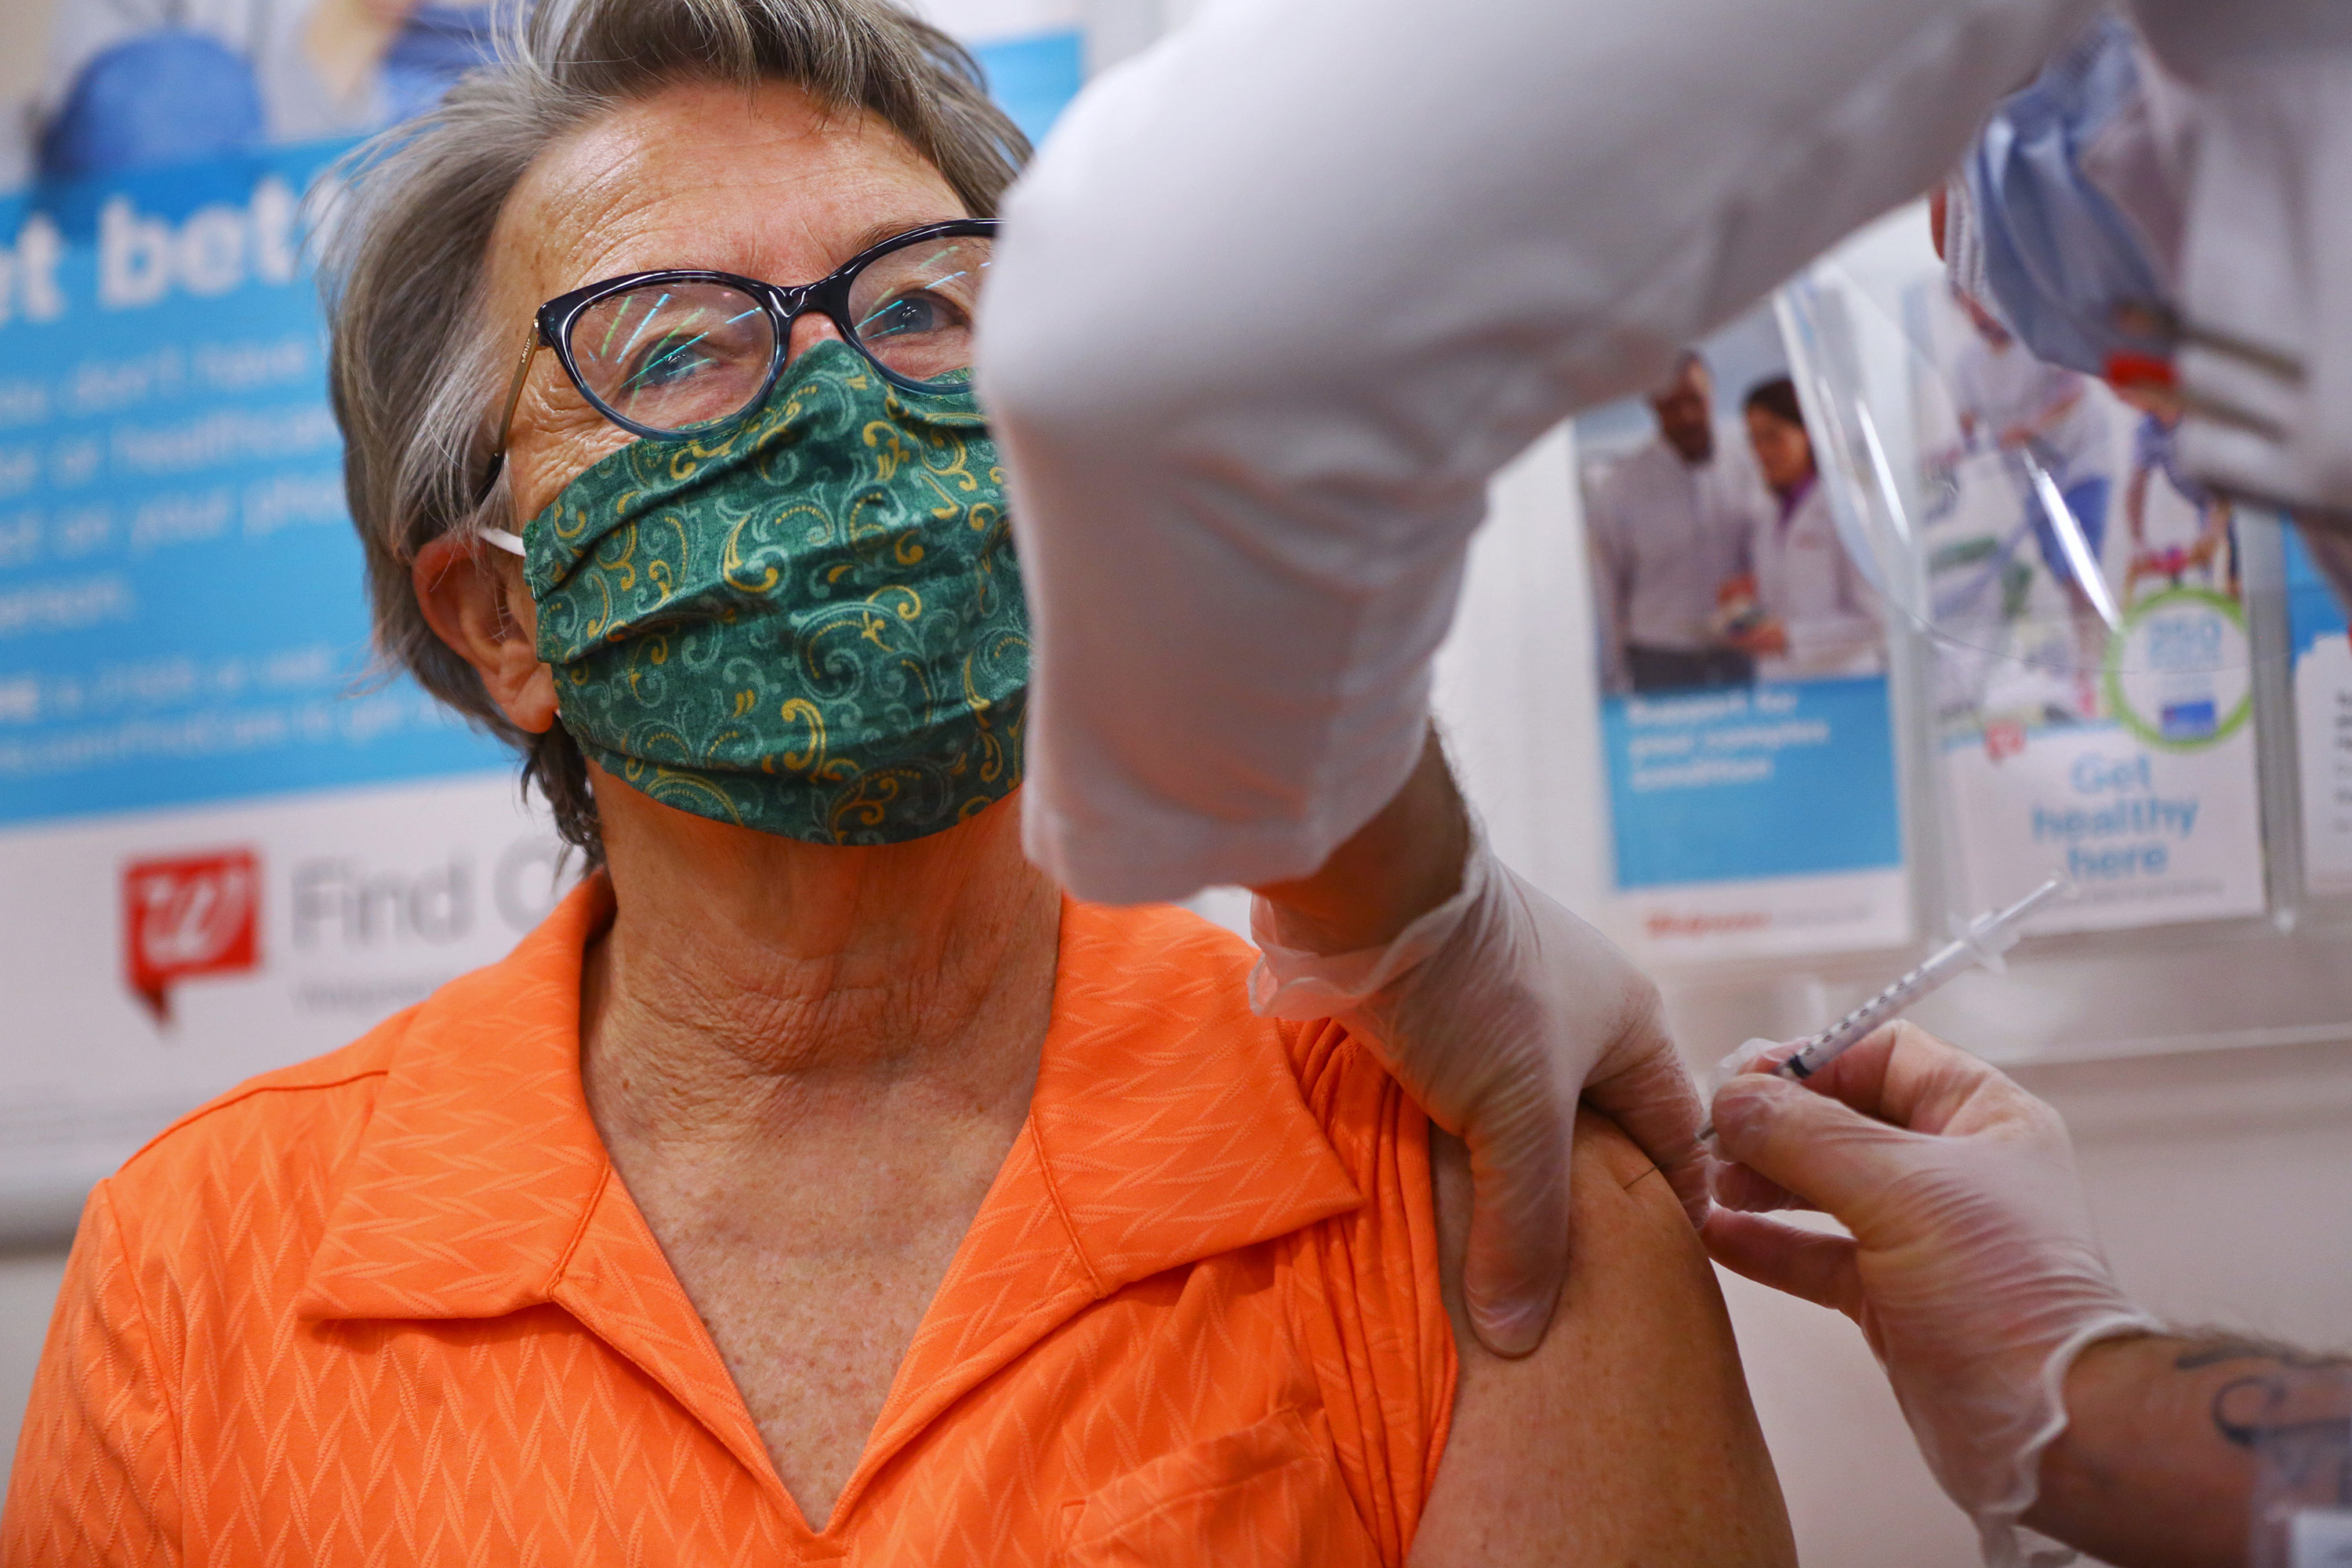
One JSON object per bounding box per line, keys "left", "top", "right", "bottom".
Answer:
{"left": 510, "top": 341, "right": 1030, "bottom": 844}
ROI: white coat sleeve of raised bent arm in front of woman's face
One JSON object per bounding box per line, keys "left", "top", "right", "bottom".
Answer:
{"left": 978, "top": 0, "right": 2093, "bottom": 900}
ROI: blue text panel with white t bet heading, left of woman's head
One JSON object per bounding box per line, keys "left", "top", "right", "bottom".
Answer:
{"left": 0, "top": 141, "right": 508, "bottom": 822}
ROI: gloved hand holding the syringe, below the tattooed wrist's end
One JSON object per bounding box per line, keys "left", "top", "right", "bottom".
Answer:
{"left": 1705, "top": 1022, "right": 2164, "bottom": 1568}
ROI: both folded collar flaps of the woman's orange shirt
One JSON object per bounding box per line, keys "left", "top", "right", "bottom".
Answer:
{"left": 296, "top": 874, "right": 1359, "bottom": 1319}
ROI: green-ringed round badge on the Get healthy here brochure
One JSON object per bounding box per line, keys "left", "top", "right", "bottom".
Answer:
{"left": 2103, "top": 588, "right": 2253, "bottom": 753}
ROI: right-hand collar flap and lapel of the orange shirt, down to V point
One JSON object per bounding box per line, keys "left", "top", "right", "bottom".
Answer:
{"left": 835, "top": 900, "right": 1359, "bottom": 1516}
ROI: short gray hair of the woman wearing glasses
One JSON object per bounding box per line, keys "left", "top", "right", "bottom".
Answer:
{"left": 325, "top": 0, "right": 1030, "bottom": 860}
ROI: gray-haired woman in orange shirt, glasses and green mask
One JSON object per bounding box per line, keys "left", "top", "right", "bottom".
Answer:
{"left": 0, "top": 0, "right": 1790, "bottom": 1568}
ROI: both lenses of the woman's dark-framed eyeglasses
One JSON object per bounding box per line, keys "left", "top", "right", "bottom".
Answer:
{"left": 572, "top": 235, "right": 990, "bottom": 433}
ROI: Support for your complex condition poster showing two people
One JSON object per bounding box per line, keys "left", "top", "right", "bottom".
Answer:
{"left": 1576, "top": 313, "right": 1910, "bottom": 961}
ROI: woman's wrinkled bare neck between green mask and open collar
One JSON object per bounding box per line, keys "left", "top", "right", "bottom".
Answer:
{"left": 581, "top": 771, "right": 1061, "bottom": 1140}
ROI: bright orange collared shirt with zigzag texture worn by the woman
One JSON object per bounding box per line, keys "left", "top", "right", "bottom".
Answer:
{"left": 0, "top": 877, "right": 1454, "bottom": 1568}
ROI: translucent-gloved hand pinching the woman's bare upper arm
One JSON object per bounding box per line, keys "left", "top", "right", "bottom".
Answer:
{"left": 1249, "top": 822, "right": 1708, "bottom": 1356}
